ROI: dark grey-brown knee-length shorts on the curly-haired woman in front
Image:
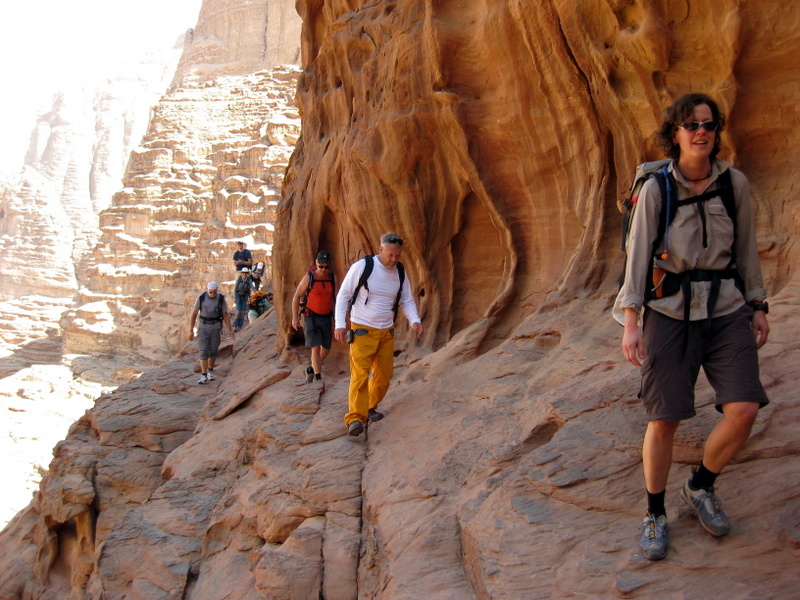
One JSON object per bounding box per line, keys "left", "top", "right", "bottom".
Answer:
{"left": 639, "top": 305, "right": 769, "bottom": 421}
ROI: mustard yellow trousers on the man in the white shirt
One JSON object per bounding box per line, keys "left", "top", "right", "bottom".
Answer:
{"left": 344, "top": 323, "right": 394, "bottom": 426}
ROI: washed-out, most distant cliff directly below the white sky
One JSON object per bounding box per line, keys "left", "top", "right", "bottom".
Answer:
{"left": 0, "top": 48, "right": 180, "bottom": 300}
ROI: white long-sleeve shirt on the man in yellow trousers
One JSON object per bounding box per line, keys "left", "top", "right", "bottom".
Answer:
{"left": 336, "top": 256, "right": 420, "bottom": 329}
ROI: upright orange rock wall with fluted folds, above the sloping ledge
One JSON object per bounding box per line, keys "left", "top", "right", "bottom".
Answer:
{"left": 274, "top": 0, "right": 800, "bottom": 351}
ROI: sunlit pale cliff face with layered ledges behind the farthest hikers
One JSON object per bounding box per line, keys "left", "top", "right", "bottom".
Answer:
{"left": 61, "top": 66, "right": 300, "bottom": 368}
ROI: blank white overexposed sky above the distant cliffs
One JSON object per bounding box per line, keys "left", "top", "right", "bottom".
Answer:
{"left": 0, "top": 0, "right": 202, "bottom": 174}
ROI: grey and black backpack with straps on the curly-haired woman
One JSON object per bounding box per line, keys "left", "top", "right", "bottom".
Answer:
{"left": 620, "top": 159, "right": 736, "bottom": 301}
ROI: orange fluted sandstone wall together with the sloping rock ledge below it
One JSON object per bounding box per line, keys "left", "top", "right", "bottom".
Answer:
{"left": 0, "top": 0, "right": 800, "bottom": 600}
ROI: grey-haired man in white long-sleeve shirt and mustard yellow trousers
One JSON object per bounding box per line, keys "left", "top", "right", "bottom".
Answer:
{"left": 334, "top": 233, "right": 422, "bottom": 435}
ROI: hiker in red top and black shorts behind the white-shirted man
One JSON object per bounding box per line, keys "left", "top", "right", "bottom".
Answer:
{"left": 292, "top": 250, "right": 336, "bottom": 383}
